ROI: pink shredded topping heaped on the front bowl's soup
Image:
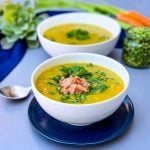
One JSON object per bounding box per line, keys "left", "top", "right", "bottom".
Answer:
{"left": 59, "top": 76, "right": 90, "bottom": 95}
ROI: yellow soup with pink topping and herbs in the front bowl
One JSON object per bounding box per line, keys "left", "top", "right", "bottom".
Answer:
{"left": 35, "top": 63, "right": 124, "bottom": 104}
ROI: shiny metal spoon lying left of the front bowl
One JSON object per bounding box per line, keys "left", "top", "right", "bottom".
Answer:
{"left": 0, "top": 85, "right": 32, "bottom": 100}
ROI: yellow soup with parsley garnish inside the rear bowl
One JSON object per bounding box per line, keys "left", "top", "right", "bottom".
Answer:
{"left": 44, "top": 24, "right": 112, "bottom": 45}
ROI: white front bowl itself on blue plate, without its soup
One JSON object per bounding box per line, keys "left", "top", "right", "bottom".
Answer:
{"left": 31, "top": 53, "right": 129, "bottom": 125}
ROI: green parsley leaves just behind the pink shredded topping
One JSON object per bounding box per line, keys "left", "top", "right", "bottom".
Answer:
{"left": 61, "top": 65, "right": 92, "bottom": 78}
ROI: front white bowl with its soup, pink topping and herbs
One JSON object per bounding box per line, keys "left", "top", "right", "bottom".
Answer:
{"left": 31, "top": 53, "right": 129, "bottom": 125}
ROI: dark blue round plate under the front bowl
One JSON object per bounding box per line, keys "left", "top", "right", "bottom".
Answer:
{"left": 28, "top": 96, "right": 134, "bottom": 145}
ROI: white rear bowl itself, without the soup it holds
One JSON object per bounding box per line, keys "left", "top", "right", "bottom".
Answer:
{"left": 37, "top": 12, "right": 121, "bottom": 56}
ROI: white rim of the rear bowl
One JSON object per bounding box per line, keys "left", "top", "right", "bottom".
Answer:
{"left": 37, "top": 12, "right": 121, "bottom": 47}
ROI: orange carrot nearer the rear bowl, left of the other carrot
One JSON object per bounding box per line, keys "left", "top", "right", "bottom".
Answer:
{"left": 117, "top": 13, "right": 144, "bottom": 26}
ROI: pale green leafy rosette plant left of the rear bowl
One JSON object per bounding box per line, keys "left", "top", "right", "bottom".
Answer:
{"left": 0, "top": 0, "right": 48, "bottom": 49}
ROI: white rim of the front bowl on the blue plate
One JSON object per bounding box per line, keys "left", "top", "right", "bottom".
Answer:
{"left": 31, "top": 53, "right": 130, "bottom": 107}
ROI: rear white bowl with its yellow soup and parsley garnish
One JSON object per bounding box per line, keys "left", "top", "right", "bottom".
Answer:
{"left": 37, "top": 12, "right": 121, "bottom": 56}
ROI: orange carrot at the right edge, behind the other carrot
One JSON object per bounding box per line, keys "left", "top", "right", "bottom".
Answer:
{"left": 127, "top": 10, "right": 150, "bottom": 27}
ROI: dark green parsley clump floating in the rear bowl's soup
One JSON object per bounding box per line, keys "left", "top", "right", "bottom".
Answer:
{"left": 67, "top": 29, "right": 90, "bottom": 40}
